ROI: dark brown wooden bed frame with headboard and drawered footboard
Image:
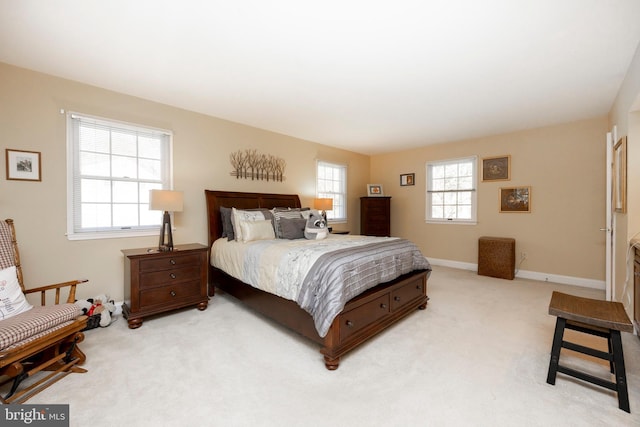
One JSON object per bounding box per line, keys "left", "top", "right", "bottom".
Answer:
{"left": 205, "top": 190, "right": 430, "bottom": 370}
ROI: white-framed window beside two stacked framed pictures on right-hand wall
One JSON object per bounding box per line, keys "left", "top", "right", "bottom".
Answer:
{"left": 426, "top": 156, "right": 478, "bottom": 224}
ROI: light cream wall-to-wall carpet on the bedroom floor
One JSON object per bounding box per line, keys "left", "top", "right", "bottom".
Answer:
{"left": 2, "top": 267, "right": 640, "bottom": 427}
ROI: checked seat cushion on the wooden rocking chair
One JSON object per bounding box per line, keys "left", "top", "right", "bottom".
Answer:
{"left": 0, "top": 303, "right": 82, "bottom": 350}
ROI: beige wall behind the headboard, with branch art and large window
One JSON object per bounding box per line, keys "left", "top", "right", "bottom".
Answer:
{"left": 0, "top": 63, "right": 369, "bottom": 300}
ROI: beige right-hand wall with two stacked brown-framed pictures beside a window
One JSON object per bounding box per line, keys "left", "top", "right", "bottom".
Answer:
{"left": 371, "top": 117, "right": 607, "bottom": 281}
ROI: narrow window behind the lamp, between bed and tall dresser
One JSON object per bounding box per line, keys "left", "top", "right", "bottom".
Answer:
{"left": 316, "top": 161, "right": 347, "bottom": 222}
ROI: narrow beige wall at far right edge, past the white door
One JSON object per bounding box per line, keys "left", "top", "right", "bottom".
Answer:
{"left": 609, "top": 41, "right": 640, "bottom": 316}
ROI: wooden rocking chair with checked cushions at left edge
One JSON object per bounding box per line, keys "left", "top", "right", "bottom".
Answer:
{"left": 0, "top": 219, "right": 87, "bottom": 403}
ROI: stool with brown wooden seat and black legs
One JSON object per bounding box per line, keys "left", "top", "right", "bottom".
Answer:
{"left": 547, "top": 292, "right": 633, "bottom": 412}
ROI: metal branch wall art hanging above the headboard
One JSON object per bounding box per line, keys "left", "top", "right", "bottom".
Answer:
{"left": 229, "top": 149, "right": 287, "bottom": 181}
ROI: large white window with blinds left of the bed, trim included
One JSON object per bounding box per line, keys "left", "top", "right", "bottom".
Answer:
{"left": 67, "top": 113, "right": 171, "bottom": 240}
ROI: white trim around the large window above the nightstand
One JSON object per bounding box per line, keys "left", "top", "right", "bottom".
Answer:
{"left": 66, "top": 111, "right": 173, "bottom": 240}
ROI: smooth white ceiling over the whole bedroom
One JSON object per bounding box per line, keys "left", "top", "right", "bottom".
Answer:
{"left": 0, "top": 0, "right": 640, "bottom": 154}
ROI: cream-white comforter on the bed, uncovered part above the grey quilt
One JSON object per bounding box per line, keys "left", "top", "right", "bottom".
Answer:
{"left": 211, "top": 234, "right": 396, "bottom": 301}
